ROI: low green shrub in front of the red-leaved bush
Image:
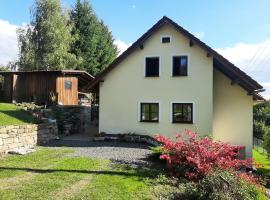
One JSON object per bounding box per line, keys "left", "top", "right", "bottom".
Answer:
{"left": 174, "top": 170, "right": 266, "bottom": 200}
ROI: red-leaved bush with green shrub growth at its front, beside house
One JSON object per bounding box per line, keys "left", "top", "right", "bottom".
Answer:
{"left": 156, "top": 130, "right": 266, "bottom": 199}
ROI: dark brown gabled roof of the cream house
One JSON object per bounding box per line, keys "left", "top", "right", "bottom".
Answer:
{"left": 88, "top": 16, "right": 264, "bottom": 100}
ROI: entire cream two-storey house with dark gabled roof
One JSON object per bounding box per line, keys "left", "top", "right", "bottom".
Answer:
{"left": 89, "top": 17, "right": 263, "bottom": 157}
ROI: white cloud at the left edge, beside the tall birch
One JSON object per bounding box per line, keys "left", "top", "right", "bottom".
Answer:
{"left": 0, "top": 19, "right": 19, "bottom": 65}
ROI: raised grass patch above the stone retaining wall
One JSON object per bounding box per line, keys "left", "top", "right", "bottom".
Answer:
{"left": 0, "top": 103, "right": 37, "bottom": 126}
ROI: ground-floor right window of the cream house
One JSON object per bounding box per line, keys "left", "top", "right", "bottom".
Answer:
{"left": 172, "top": 103, "right": 193, "bottom": 123}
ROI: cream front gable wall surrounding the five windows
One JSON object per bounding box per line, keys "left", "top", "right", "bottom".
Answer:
{"left": 99, "top": 25, "right": 213, "bottom": 136}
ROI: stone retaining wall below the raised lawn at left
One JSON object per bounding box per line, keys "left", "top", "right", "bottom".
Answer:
{"left": 0, "top": 123, "right": 58, "bottom": 155}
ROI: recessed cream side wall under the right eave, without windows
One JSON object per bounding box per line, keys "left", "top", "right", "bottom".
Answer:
{"left": 213, "top": 70, "right": 253, "bottom": 157}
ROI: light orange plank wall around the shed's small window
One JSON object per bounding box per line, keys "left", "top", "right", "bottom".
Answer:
{"left": 56, "top": 76, "right": 78, "bottom": 105}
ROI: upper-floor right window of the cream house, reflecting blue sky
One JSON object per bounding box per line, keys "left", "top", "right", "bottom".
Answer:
{"left": 172, "top": 56, "right": 188, "bottom": 76}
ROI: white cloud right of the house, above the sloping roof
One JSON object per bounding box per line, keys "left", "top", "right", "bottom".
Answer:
{"left": 216, "top": 39, "right": 270, "bottom": 98}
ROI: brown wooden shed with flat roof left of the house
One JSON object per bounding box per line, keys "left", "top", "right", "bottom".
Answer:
{"left": 0, "top": 70, "right": 94, "bottom": 105}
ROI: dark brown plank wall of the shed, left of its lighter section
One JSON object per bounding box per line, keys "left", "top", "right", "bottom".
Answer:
{"left": 13, "top": 73, "right": 57, "bottom": 104}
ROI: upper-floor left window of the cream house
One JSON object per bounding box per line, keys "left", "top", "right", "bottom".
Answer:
{"left": 145, "top": 57, "right": 159, "bottom": 77}
